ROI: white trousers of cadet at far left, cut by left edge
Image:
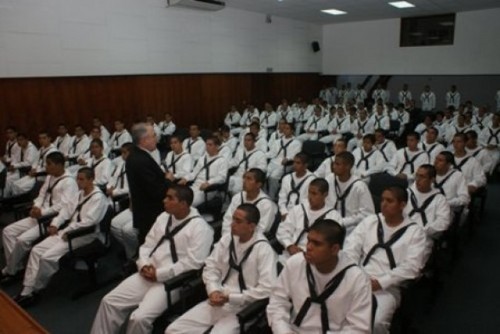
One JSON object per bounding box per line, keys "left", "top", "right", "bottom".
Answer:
{"left": 2, "top": 217, "right": 40, "bottom": 275}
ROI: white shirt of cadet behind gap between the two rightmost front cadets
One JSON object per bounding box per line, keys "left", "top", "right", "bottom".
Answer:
{"left": 326, "top": 174, "right": 375, "bottom": 233}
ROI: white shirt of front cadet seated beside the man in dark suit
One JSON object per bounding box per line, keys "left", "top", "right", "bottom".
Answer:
{"left": 137, "top": 208, "right": 214, "bottom": 282}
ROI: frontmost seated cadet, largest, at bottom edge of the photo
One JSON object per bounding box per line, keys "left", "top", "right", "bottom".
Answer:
{"left": 267, "top": 219, "right": 372, "bottom": 334}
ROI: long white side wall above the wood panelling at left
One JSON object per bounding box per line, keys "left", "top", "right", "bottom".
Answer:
{"left": 0, "top": 0, "right": 322, "bottom": 77}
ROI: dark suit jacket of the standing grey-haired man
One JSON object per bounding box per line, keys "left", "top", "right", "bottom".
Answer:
{"left": 126, "top": 147, "right": 167, "bottom": 244}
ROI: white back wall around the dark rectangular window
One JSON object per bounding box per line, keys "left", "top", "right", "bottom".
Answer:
{"left": 322, "top": 8, "right": 500, "bottom": 75}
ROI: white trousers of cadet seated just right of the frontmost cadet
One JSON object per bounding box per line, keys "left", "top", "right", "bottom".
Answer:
{"left": 373, "top": 288, "right": 401, "bottom": 334}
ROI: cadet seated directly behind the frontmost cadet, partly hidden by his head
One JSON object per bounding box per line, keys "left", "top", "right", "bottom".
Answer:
{"left": 276, "top": 178, "right": 342, "bottom": 259}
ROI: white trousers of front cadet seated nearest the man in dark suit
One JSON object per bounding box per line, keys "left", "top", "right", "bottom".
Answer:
{"left": 91, "top": 273, "right": 179, "bottom": 334}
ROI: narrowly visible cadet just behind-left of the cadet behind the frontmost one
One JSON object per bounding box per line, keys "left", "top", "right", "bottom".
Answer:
{"left": 278, "top": 153, "right": 316, "bottom": 220}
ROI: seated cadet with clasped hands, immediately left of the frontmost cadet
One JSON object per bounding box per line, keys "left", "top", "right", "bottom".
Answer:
{"left": 165, "top": 204, "right": 276, "bottom": 334}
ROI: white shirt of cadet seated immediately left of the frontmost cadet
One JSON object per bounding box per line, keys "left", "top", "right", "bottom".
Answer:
{"left": 203, "top": 233, "right": 276, "bottom": 309}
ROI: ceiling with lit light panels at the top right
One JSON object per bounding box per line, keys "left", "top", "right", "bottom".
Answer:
{"left": 225, "top": 0, "right": 500, "bottom": 24}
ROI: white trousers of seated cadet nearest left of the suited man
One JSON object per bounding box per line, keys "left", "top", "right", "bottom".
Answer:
{"left": 23, "top": 234, "right": 96, "bottom": 291}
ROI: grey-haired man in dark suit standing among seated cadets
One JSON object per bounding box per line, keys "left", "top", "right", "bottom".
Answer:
{"left": 126, "top": 123, "right": 167, "bottom": 245}
